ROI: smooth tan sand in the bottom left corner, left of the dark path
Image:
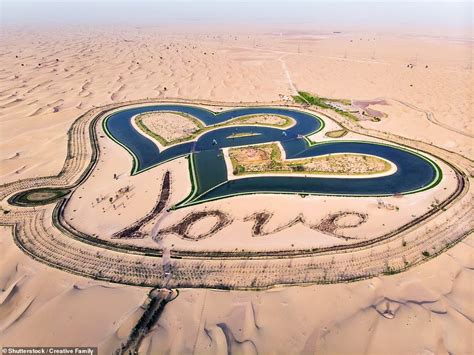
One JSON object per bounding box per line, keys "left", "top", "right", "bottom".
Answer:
{"left": 0, "top": 227, "right": 146, "bottom": 353}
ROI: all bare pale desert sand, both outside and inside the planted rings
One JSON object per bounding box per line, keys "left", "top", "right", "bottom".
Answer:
{"left": 0, "top": 20, "right": 474, "bottom": 354}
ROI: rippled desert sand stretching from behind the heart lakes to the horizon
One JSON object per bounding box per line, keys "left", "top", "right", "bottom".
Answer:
{"left": 0, "top": 29, "right": 472, "bottom": 186}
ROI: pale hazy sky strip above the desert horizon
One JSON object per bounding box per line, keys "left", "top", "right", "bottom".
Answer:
{"left": 0, "top": 0, "right": 473, "bottom": 33}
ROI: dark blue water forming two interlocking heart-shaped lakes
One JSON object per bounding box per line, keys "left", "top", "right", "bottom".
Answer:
{"left": 105, "top": 105, "right": 438, "bottom": 205}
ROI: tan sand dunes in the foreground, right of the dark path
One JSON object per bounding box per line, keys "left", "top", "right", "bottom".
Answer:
{"left": 142, "top": 237, "right": 473, "bottom": 354}
